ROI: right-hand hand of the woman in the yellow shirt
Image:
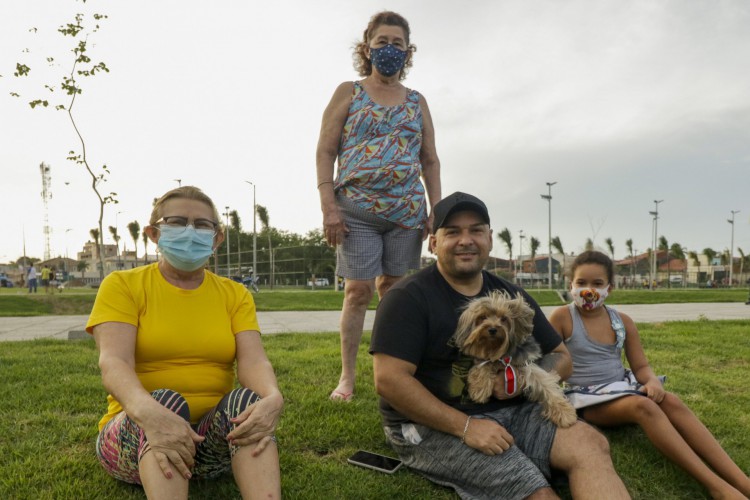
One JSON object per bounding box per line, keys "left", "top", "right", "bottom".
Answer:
{"left": 227, "top": 393, "right": 284, "bottom": 456}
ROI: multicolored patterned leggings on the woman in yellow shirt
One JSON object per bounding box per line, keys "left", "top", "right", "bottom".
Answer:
{"left": 96, "top": 387, "right": 260, "bottom": 484}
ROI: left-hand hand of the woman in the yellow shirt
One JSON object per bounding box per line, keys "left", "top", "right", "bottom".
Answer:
{"left": 142, "top": 406, "right": 205, "bottom": 479}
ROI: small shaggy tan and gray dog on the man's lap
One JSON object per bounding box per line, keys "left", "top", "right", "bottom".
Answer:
{"left": 454, "top": 291, "right": 577, "bottom": 427}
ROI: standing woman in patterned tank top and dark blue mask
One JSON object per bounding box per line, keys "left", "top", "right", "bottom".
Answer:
{"left": 316, "top": 12, "right": 441, "bottom": 401}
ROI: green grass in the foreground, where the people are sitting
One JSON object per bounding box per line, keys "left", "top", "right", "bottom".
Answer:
{"left": 0, "top": 322, "right": 750, "bottom": 500}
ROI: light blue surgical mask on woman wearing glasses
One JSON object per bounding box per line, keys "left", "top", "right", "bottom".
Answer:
{"left": 157, "top": 224, "right": 215, "bottom": 271}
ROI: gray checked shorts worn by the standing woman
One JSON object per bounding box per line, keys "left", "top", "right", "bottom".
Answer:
{"left": 336, "top": 196, "right": 422, "bottom": 280}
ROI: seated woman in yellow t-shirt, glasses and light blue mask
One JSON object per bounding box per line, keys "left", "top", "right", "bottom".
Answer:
{"left": 86, "top": 186, "right": 284, "bottom": 499}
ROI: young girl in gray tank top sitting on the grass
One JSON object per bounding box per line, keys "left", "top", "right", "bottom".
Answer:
{"left": 550, "top": 251, "right": 750, "bottom": 498}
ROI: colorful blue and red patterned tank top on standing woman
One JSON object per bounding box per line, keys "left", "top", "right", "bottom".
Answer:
{"left": 334, "top": 82, "right": 427, "bottom": 229}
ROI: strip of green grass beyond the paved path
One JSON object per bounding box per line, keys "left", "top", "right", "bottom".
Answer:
{"left": 0, "top": 288, "right": 748, "bottom": 316}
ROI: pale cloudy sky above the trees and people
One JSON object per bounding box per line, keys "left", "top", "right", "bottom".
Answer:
{"left": 0, "top": 0, "right": 750, "bottom": 263}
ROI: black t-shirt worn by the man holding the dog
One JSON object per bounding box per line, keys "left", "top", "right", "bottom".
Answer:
{"left": 370, "top": 265, "right": 562, "bottom": 425}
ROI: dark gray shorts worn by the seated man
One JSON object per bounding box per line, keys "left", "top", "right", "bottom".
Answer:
{"left": 385, "top": 402, "right": 557, "bottom": 500}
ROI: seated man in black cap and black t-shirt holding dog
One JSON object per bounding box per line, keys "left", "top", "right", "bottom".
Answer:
{"left": 370, "top": 192, "right": 629, "bottom": 499}
